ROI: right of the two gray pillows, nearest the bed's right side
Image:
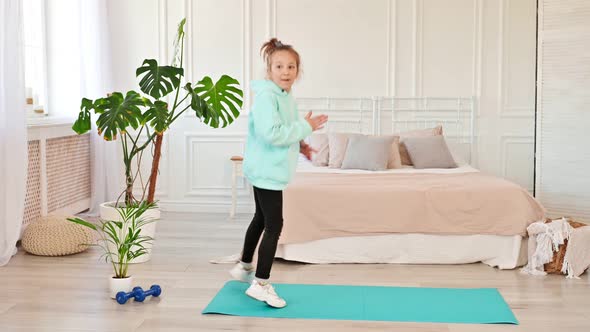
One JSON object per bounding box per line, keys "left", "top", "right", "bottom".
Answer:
{"left": 402, "top": 135, "right": 457, "bottom": 168}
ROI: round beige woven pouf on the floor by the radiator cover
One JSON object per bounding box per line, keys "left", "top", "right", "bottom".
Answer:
{"left": 21, "top": 215, "right": 94, "bottom": 256}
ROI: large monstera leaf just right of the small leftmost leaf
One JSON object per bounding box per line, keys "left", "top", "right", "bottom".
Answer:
{"left": 94, "top": 91, "right": 146, "bottom": 141}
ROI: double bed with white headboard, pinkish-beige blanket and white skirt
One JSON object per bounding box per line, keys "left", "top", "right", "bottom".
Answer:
{"left": 276, "top": 98, "right": 545, "bottom": 269}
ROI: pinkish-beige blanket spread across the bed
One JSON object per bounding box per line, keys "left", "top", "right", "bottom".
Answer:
{"left": 279, "top": 172, "right": 545, "bottom": 244}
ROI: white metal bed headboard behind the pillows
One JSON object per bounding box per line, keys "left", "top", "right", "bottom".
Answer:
{"left": 297, "top": 97, "right": 477, "bottom": 165}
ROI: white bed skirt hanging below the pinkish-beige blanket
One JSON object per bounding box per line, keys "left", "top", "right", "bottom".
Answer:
{"left": 275, "top": 234, "right": 527, "bottom": 269}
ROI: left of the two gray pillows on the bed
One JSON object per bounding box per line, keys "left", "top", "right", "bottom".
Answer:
{"left": 340, "top": 135, "right": 395, "bottom": 171}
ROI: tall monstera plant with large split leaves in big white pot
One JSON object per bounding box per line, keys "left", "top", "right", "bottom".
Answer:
{"left": 72, "top": 19, "right": 243, "bottom": 263}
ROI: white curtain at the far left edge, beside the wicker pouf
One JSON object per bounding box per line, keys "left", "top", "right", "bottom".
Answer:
{"left": 0, "top": 0, "right": 28, "bottom": 266}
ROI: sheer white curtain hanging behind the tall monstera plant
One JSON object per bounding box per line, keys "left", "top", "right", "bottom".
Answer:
{"left": 79, "top": 0, "right": 123, "bottom": 216}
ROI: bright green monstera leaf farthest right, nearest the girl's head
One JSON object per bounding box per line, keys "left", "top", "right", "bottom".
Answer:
{"left": 185, "top": 75, "right": 244, "bottom": 128}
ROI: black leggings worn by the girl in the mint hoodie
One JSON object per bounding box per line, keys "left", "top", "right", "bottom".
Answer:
{"left": 242, "top": 187, "right": 283, "bottom": 279}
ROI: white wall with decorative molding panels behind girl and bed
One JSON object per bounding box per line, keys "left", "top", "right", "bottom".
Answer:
{"left": 109, "top": 0, "right": 536, "bottom": 211}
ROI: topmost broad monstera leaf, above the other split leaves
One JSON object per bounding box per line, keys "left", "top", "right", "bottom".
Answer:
{"left": 135, "top": 59, "right": 184, "bottom": 99}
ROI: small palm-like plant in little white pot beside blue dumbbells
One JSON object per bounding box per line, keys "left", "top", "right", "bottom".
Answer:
{"left": 67, "top": 201, "right": 154, "bottom": 299}
